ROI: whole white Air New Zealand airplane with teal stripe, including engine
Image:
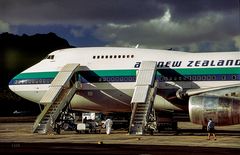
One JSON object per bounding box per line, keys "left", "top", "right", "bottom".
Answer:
{"left": 9, "top": 47, "right": 240, "bottom": 134}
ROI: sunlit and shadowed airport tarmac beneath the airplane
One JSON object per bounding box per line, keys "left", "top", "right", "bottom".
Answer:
{"left": 0, "top": 118, "right": 240, "bottom": 155}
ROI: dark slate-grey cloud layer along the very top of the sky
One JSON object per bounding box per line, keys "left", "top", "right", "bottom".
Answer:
{"left": 0, "top": 0, "right": 239, "bottom": 24}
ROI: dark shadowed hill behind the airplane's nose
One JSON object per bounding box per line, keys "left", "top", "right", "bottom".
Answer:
{"left": 0, "top": 33, "right": 72, "bottom": 116}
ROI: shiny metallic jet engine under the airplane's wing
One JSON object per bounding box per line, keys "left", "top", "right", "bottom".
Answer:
{"left": 188, "top": 95, "right": 240, "bottom": 126}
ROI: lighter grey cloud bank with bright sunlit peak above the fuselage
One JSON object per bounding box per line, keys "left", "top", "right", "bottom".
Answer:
{"left": 96, "top": 0, "right": 240, "bottom": 51}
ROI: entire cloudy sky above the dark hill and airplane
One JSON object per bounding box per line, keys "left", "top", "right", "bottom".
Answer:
{"left": 0, "top": 0, "right": 240, "bottom": 52}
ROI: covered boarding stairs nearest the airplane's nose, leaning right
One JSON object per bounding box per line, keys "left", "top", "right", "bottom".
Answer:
{"left": 32, "top": 64, "right": 81, "bottom": 134}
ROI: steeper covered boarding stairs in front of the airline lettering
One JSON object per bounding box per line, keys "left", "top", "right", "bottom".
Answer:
{"left": 129, "top": 61, "right": 158, "bottom": 135}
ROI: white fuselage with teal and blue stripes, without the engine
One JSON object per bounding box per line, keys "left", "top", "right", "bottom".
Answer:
{"left": 9, "top": 47, "right": 240, "bottom": 112}
